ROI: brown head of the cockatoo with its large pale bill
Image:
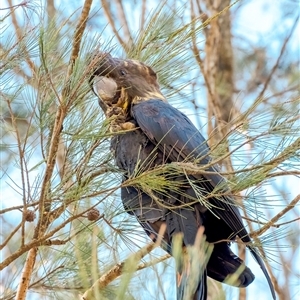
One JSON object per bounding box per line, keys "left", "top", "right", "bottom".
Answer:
{"left": 91, "top": 53, "right": 165, "bottom": 112}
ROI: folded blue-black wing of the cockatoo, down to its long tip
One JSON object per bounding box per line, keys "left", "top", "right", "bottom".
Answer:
{"left": 132, "top": 99, "right": 276, "bottom": 299}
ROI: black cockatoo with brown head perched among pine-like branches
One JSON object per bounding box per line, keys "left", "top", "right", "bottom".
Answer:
{"left": 89, "top": 52, "right": 276, "bottom": 300}
